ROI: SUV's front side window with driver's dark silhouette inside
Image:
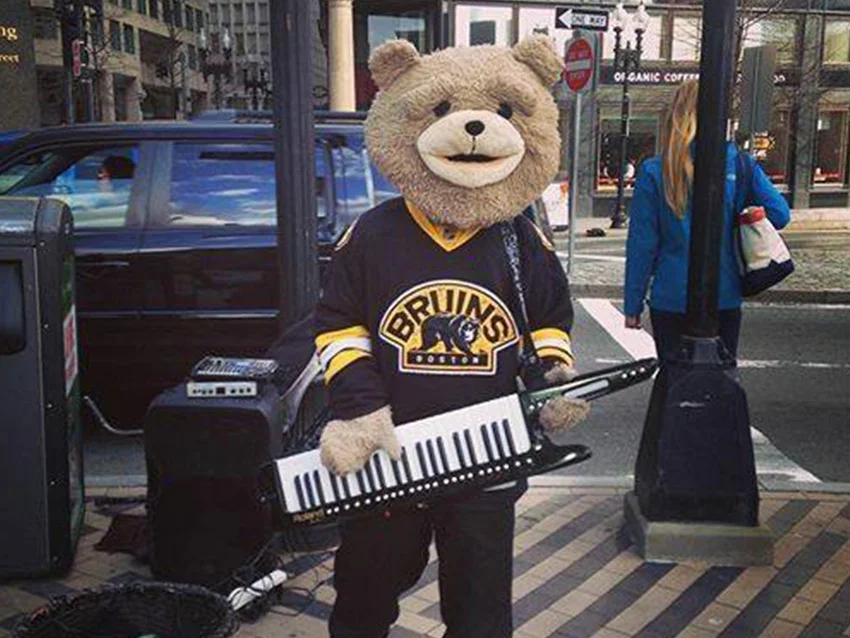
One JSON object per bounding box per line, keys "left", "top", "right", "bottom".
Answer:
{"left": 0, "top": 144, "right": 139, "bottom": 228}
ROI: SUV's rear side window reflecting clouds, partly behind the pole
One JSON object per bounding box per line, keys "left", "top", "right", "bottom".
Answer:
{"left": 160, "top": 142, "right": 326, "bottom": 227}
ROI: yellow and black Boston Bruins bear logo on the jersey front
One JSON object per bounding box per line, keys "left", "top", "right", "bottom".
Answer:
{"left": 378, "top": 279, "right": 518, "bottom": 375}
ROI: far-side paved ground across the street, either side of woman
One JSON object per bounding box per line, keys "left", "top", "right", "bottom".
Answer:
{"left": 555, "top": 209, "right": 850, "bottom": 304}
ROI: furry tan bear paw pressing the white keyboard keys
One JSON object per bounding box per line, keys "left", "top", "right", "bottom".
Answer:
{"left": 319, "top": 406, "right": 401, "bottom": 474}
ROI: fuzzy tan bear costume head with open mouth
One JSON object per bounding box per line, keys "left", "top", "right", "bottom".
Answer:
{"left": 365, "top": 35, "right": 562, "bottom": 229}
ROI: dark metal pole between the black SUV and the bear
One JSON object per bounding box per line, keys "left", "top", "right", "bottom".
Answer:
{"left": 271, "top": 0, "right": 319, "bottom": 328}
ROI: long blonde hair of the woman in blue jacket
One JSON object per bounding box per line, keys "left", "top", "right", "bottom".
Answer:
{"left": 661, "top": 80, "right": 699, "bottom": 219}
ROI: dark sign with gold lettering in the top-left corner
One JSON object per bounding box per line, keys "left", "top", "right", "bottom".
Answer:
{"left": 0, "top": 0, "right": 39, "bottom": 131}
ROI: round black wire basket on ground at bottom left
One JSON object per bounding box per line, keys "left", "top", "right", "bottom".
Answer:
{"left": 12, "top": 582, "right": 239, "bottom": 638}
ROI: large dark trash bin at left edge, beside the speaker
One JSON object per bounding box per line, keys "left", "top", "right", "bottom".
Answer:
{"left": 0, "top": 197, "right": 85, "bottom": 578}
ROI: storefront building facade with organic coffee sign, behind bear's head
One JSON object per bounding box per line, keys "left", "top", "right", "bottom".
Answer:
{"left": 328, "top": 0, "right": 850, "bottom": 217}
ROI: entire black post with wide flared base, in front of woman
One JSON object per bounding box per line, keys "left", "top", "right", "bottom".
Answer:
{"left": 627, "top": 0, "right": 770, "bottom": 536}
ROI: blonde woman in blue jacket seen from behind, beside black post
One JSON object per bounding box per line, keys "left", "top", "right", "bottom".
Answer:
{"left": 624, "top": 80, "right": 791, "bottom": 356}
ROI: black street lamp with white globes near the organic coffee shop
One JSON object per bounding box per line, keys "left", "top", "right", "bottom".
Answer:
{"left": 611, "top": 0, "right": 649, "bottom": 228}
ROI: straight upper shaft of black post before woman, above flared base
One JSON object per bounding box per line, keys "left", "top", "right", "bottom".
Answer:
{"left": 686, "top": 0, "right": 736, "bottom": 337}
